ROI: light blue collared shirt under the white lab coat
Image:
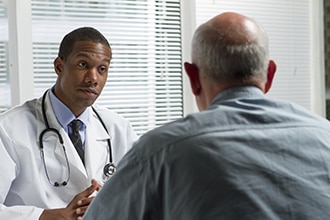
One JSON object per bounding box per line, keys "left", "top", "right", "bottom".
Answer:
{"left": 49, "top": 89, "right": 90, "bottom": 146}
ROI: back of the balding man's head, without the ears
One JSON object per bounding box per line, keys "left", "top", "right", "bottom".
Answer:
{"left": 192, "top": 12, "right": 269, "bottom": 85}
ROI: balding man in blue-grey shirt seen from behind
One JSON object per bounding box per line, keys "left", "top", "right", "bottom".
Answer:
{"left": 84, "top": 12, "right": 330, "bottom": 220}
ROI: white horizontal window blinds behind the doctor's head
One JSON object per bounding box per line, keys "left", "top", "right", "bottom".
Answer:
{"left": 32, "top": 0, "right": 183, "bottom": 134}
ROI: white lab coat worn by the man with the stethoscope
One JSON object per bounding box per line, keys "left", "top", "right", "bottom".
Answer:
{"left": 0, "top": 90, "right": 137, "bottom": 220}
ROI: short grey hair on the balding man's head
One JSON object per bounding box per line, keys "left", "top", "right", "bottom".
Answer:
{"left": 192, "top": 20, "right": 269, "bottom": 84}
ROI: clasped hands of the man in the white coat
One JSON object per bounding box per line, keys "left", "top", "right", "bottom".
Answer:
{"left": 39, "top": 179, "right": 101, "bottom": 220}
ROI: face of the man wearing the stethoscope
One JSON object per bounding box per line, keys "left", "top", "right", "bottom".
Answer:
{"left": 54, "top": 41, "right": 111, "bottom": 116}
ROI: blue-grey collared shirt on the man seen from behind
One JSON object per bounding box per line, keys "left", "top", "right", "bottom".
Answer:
{"left": 84, "top": 87, "right": 330, "bottom": 220}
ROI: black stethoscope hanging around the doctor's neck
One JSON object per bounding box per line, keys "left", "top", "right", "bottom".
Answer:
{"left": 39, "top": 91, "right": 116, "bottom": 187}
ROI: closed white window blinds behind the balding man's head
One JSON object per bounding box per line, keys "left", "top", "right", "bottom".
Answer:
{"left": 196, "top": 0, "right": 313, "bottom": 109}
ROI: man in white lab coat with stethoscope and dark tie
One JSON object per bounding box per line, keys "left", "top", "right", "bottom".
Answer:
{"left": 0, "top": 27, "right": 137, "bottom": 220}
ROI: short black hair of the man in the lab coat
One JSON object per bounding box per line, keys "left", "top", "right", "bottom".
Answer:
{"left": 58, "top": 27, "right": 111, "bottom": 59}
